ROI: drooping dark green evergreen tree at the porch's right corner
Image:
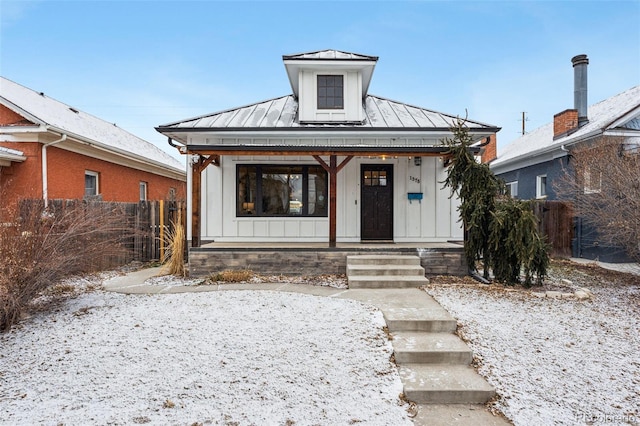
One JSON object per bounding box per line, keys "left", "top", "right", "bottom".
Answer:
{"left": 443, "top": 119, "right": 549, "bottom": 286}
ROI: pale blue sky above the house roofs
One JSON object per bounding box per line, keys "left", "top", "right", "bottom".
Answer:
{"left": 0, "top": 0, "right": 640, "bottom": 161}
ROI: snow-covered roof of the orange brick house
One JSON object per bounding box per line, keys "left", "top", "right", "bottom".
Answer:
{"left": 0, "top": 77, "right": 185, "bottom": 173}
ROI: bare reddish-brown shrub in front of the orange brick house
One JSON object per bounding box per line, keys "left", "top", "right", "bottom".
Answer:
{"left": 0, "top": 200, "right": 132, "bottom": 331}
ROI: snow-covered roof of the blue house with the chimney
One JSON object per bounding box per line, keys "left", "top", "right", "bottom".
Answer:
{"left": 491, "top": 86, "right": 640, "bottom": 168}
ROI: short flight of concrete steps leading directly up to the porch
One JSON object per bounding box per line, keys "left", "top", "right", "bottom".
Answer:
{"left": 347, "top": 255, "right": 429, "bottom": 288}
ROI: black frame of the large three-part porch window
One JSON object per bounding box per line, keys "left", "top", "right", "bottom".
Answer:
{"left": 240, "top": 163, "right": 329, "bottom": 219}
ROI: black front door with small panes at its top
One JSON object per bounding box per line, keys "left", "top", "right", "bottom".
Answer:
{"left": 360, "top": 164, "right": 393, "bottom": 240}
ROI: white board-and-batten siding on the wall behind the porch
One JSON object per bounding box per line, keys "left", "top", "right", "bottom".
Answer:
{"left": 187, "top": 152, "right": 463, "bottom": 243}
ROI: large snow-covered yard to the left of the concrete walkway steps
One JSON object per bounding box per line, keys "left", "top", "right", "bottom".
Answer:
{"left": 0, "top": 278, "right": 411, "bottom": 425}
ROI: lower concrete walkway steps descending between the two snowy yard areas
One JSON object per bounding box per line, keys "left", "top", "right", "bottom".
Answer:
{"left": 338, "top": 288, "right": 510, "bottom": 426}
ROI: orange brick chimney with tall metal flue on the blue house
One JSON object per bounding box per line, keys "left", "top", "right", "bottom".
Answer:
{"left": 553, "top": 55, "right": 589, "bottom": 139}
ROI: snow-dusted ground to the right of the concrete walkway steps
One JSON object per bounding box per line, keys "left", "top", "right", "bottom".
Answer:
{"left": 427, "top": 262, "right": 640, "bottom": 426}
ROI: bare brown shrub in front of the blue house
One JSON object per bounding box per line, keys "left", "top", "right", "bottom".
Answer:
{"left": 555, "top": 137, "right": 640, "bottom": 261}
